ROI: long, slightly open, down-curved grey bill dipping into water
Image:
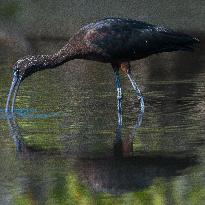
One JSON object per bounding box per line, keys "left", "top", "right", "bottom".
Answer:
{"left": 6, "top": 73, "right": 22, "bottom": 113}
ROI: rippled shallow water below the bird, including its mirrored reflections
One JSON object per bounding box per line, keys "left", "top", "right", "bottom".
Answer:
{"left": 0, "top": 36, "right": 205, "bottom": 205}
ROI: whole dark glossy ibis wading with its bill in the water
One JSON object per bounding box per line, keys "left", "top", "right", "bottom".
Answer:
{"left": 6, "top": 18, "right": 199, "bottom": 118}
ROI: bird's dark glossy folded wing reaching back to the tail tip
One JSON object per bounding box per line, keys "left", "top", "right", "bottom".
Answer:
{"left": 82, "top": 19, "right": 199, "bottom": 59}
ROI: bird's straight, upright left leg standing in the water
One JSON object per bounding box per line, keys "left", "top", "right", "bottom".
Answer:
{"left": 114, "top": 68, "right": 122, "bottom": 127}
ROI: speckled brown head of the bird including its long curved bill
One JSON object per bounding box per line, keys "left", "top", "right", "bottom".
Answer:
{"left": 6, "top": 56, "right": 40, "bottom": 112}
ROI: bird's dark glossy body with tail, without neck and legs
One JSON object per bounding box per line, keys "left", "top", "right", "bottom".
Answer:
{"left": 65, "top": 18, "right": 197, "bottom": 63}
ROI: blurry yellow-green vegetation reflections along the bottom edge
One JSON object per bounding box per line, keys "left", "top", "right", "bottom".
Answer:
{"left": 15, "top": 171, "right": 205, "bottom": 205}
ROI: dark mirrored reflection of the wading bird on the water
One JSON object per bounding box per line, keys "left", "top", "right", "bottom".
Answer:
{"left": 8, "top": 110, "right": 197, "bottom": 195}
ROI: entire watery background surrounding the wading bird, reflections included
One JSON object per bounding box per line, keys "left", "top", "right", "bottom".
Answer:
{"left": 0, "top": 0, "right": 205, "bottom": 205}
